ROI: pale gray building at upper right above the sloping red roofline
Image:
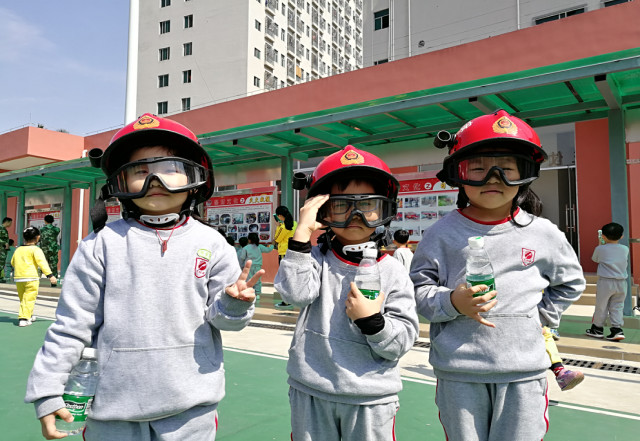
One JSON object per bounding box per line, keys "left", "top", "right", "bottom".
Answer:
{"left": 364, "top": 0, "right": 631, "bottom": 69}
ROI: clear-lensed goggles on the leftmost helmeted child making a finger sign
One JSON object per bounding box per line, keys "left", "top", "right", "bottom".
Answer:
{"left": 107, "top": 157, "right": 208, "bottom": 199}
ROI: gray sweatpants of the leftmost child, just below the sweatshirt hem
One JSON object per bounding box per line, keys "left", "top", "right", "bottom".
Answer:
{"left": 84, "top": 404, "right": 218, "bottom": 441}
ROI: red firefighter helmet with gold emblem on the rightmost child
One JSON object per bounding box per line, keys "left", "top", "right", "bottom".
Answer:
{"left": 434, "top": 109, "right": 547, "bottom": 185}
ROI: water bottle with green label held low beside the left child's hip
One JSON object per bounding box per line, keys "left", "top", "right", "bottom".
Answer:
{"left": 56, "top": 348, "right": 98, "bottom": 435}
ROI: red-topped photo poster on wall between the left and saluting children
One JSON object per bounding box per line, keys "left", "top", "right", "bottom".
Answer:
{"left": 205, "top": 187, "right": 276, "bottom": 243}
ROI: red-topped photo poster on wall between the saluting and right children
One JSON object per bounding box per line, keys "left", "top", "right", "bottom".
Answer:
{"left": 390, "top": 176, "right": 458, "bottom": 242}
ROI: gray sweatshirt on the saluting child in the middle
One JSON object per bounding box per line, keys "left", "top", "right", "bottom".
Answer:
{"left": 274, "top": 247, "right": 418, "bottom": 404}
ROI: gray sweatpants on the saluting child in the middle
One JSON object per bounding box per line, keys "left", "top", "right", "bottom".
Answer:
{"left": 289, "top": 388, "right": 398, "bottom": 441}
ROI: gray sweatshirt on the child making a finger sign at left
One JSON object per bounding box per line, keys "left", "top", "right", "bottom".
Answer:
{"left": 25, "top": 219, "right": 254, "bottom": 421}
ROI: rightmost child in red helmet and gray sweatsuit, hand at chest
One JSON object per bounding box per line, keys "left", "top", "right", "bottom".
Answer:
{"left": 411, "top": 110, "right": 585, "bottom": 441}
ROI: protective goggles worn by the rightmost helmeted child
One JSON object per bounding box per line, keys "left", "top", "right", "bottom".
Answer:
{"left": 448, "top": 152, "right": 540, "bottom": 187}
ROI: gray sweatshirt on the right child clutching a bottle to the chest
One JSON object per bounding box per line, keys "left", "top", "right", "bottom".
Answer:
{"left": 411, "top": 210, "right": 585, "bottom": 383}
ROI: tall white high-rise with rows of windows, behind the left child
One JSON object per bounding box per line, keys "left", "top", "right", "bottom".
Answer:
{"left": 134, "top": 0, "right": 363, "bottom": 115}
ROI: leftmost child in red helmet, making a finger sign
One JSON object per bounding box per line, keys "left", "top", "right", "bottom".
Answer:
{"left": 25, "top": 114, "right": 264, "bottom": 441}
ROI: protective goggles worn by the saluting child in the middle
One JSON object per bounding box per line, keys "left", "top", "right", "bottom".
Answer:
{"left": 317, "top": 194, "right": 398, "bottom": 228}
